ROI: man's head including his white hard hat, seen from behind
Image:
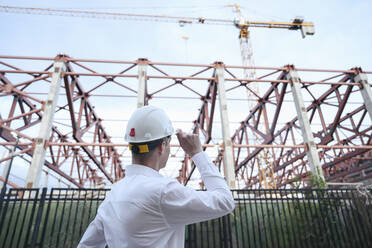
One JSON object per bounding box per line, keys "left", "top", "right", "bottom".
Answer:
{"left": 125, "top": 106, "right": 174, "bottom": 169}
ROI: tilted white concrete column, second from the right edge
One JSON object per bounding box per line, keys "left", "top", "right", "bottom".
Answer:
{"left": 287, "top": 70, "right": 324, "bottom": 181}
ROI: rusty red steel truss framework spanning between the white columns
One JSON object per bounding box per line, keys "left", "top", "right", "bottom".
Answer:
{"left": 0, "top": 55, "right": 372, "bottom": 188}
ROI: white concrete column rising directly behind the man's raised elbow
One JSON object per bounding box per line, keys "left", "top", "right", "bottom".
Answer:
{"left": 216, "top": 64, "right": 235, "bottom": 189}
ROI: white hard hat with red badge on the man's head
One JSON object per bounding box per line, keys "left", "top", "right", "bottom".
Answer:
{"left": 125, "top": 106, "right": 174, "bottom": 143}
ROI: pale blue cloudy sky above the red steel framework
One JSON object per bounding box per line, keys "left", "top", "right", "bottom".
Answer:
{"left": 0, "top": 0, "right": 372, "bottom": 188}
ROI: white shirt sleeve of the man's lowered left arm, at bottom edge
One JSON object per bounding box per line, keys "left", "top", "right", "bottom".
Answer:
{"left": 77, "top": 215, "right": 106, "bottom": 248}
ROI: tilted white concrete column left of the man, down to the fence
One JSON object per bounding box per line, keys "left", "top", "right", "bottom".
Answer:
{"left": 26, "top": 61, "right": 66, "bottom": 188}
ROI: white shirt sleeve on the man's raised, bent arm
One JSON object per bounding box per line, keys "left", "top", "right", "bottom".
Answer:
{"left": 160, "top": 152, "right": 235, "bottom": 225}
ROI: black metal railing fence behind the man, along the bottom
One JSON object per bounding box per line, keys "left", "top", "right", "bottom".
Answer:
{"left": 0, "top": 189, "right": 372, "bottom": 247}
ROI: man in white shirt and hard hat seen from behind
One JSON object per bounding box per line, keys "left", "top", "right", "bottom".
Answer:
{"left": 78, "top": 106, "right": 234, "bottom": 248}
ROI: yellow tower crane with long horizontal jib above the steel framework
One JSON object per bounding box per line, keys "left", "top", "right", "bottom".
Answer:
{"left": 0, "top": 4, "right": 315, "bottom": 188}
